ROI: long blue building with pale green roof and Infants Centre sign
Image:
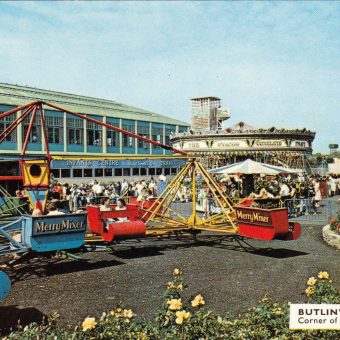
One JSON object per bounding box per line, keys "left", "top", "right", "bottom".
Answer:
{"left": 0, "top": 83, "right": 189, "bottom": 181}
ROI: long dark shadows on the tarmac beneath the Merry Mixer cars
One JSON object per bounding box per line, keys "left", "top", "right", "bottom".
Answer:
{"left": 4, "top": 235, "right": 308, "bottom": 282}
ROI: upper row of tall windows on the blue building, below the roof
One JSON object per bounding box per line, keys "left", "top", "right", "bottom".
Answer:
{"left": 0, "top": 114, "right": 186, "bottom": 149}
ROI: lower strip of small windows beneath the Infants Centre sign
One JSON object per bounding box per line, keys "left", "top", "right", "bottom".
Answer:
{"left": 51, "top": 168, "right": 178, "bottom": 178}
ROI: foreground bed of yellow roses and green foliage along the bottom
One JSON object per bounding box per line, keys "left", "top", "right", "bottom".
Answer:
{"left": 6, "top": 269, "right": 340, "bottom": 340}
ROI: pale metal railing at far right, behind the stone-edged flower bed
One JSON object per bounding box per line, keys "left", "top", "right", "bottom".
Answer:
{"left": 283, "top": 198, "right": 340, "bottom": 222}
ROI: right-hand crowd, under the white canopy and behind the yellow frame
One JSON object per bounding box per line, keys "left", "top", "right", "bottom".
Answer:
{"left": 176, "top": 174, "right": 340, "bottom": 216}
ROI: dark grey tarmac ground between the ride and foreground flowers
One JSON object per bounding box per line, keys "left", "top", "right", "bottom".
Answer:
{"left": 0, "top": 220, "right": 340, "bottom": 328}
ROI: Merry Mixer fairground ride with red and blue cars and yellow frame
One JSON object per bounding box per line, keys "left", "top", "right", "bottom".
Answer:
{"left": 0, "top": 101, "right": 301, "bottom": 300}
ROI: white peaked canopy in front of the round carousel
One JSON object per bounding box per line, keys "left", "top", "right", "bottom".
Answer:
{"left": 209, "top": 159, "right": 302, "bottom": 175}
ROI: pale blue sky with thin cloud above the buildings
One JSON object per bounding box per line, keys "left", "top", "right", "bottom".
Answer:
{"left": 0, "top": 1, "right": 340, "bottom": 152}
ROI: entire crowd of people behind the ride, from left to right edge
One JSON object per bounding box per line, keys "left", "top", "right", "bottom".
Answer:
{"left": 17, "top": 174, "right": 340, "bottom": 215}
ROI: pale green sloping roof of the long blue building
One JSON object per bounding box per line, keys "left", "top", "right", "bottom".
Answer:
{"left": 0, "top": 83, "right": 190, "bottom": 126}
